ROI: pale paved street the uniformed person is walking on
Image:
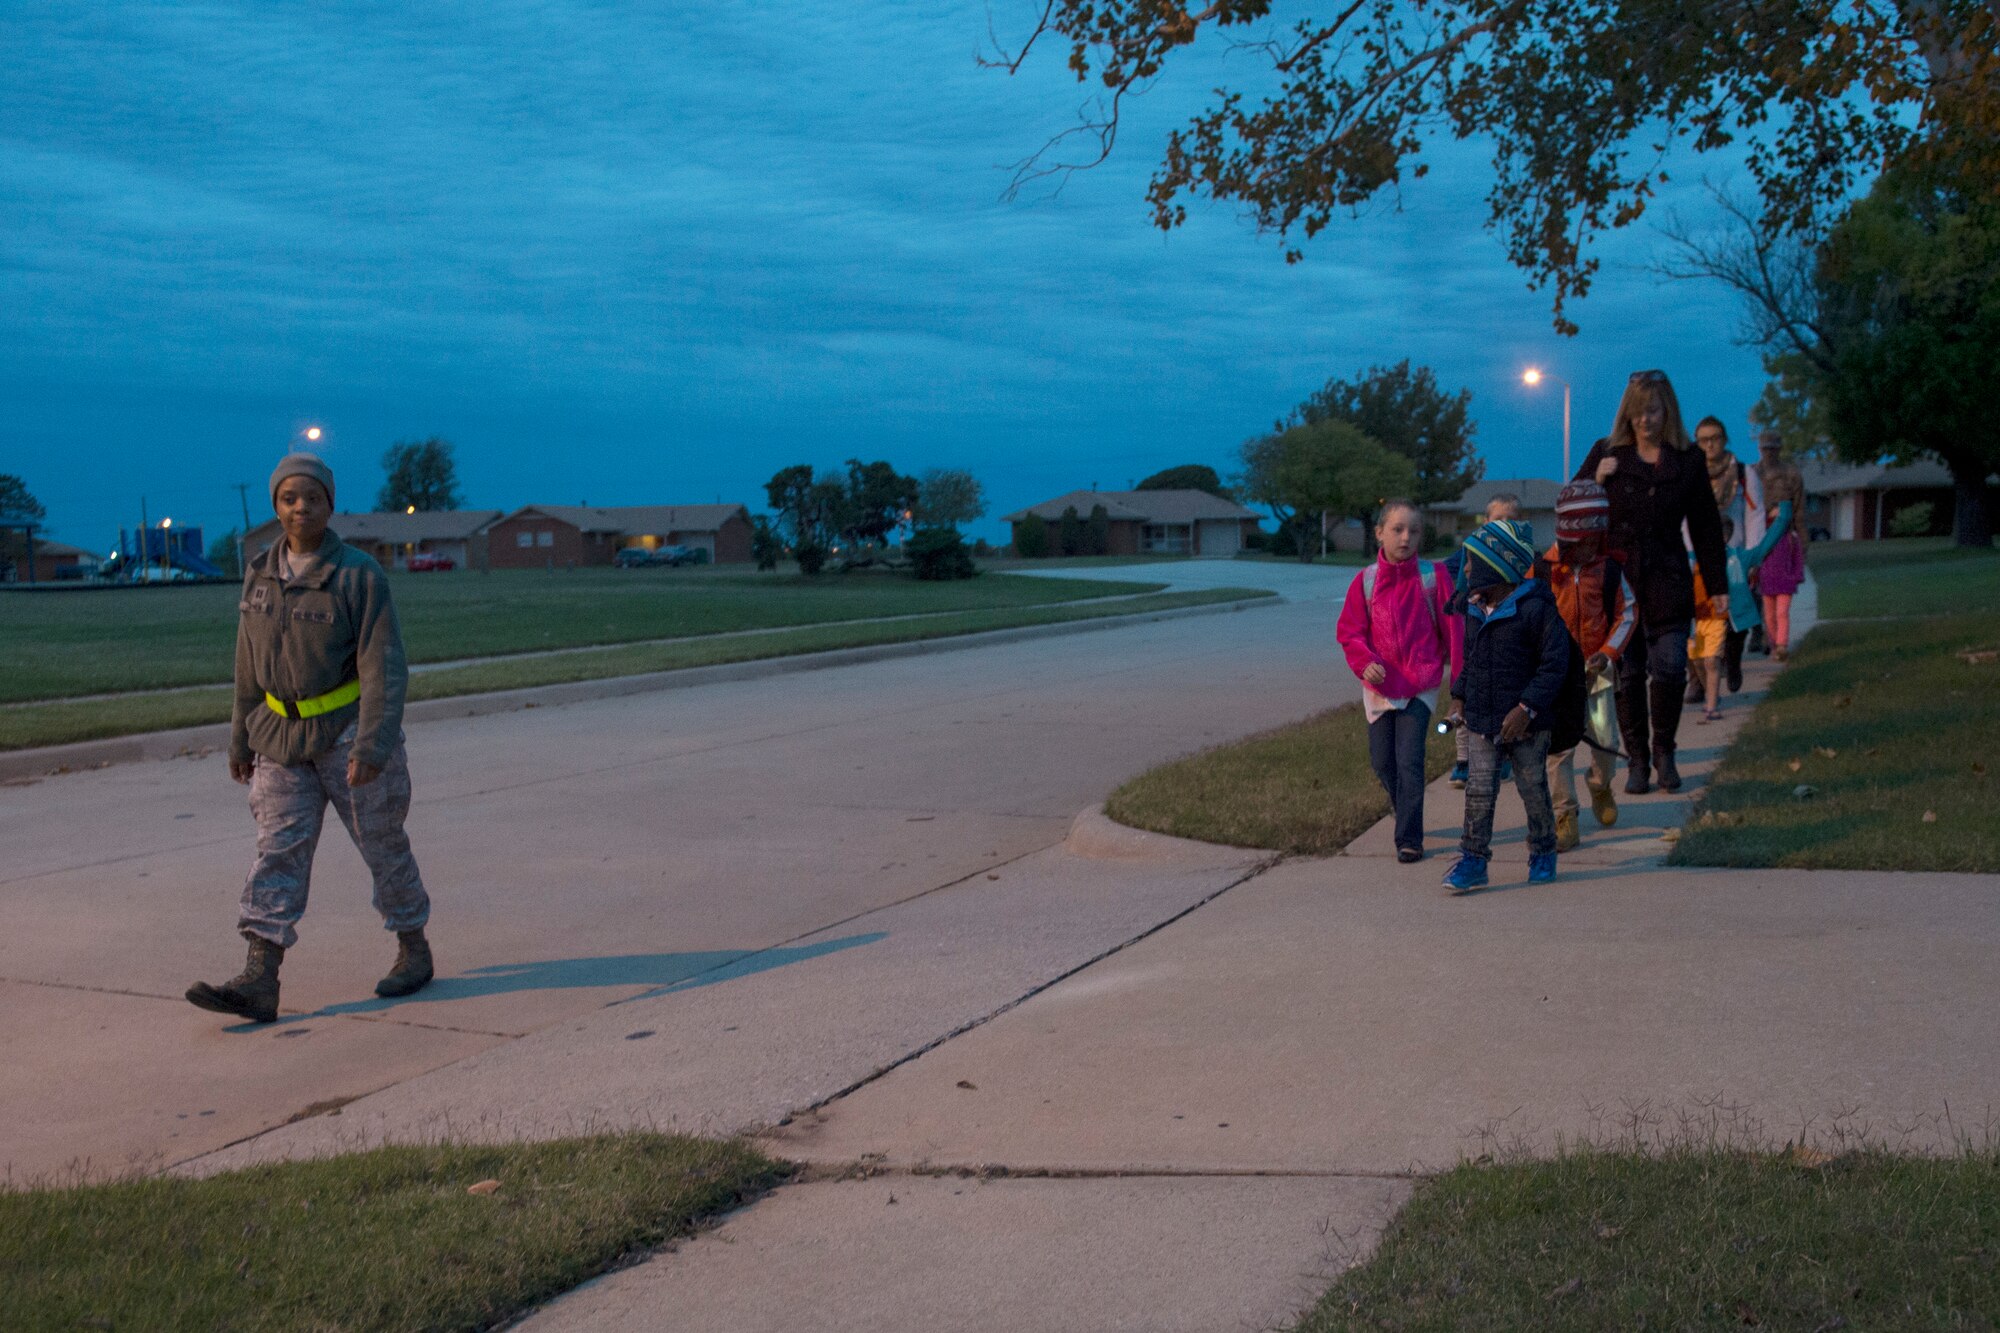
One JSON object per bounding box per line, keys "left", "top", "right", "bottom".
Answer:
{"left": 0, "top": 562, "right": 1354, "bottom": 1179}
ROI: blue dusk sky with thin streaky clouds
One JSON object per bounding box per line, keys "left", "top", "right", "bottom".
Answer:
{"left": 0, "top": 0, "right": 1762, "bottom": 548}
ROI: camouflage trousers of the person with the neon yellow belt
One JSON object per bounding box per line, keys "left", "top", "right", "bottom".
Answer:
{"left": 236, "top": 725, "right": 430, "bottom": 949}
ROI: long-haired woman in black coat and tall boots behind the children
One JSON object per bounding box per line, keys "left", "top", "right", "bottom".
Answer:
{"left": 1576, "top": 370, "right": 1730, "bottom": 795}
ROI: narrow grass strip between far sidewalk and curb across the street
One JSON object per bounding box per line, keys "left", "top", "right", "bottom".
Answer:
{"left": 0, "top": 578, "right": 1268, "bottom": 751}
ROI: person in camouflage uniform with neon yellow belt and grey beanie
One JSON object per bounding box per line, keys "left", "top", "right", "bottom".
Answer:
{"left": 188, "top": 454, "right": 432, "bottom": 1023}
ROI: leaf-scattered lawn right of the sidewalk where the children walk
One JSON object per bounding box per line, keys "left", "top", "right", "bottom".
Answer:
{"left": 1672, "top": 608, "right": 2000, "bottom": 873}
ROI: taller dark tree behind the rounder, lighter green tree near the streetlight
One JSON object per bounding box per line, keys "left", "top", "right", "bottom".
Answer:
{"left": 1280, "top": 360, "right": 1486, "bottom": 506}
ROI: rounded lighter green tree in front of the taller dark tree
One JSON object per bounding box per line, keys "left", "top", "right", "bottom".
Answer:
{"left": 1240, "top": 420, "right": 1416, "bottom": 562}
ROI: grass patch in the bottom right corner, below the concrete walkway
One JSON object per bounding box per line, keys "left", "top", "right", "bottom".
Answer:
{"left": 1298, "top": 1149, "right": 2000, "bottom": 1333}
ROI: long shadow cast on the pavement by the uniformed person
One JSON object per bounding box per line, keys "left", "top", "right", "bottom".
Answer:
{"left": 224, "top": 931, "right": 888, "bottom": 1033}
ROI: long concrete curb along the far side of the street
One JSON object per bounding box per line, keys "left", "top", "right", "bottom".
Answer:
{"left": 0, "top": 594, "right": 1284, "bottom": 780}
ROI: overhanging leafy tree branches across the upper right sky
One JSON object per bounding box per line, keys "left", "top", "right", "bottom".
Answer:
{"left": 988, "top": 0, "right": 2000, "bottom": 332}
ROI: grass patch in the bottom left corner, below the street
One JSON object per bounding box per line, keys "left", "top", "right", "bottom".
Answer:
{"left": 0, "top": 1135, "right": 782, "bottom": 1333}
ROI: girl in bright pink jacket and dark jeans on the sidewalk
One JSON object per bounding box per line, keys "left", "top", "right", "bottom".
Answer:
{"left": 1336, "top": 500, "right": 1464, "bottom": 865}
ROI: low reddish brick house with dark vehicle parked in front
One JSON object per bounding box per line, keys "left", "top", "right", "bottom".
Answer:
{"left": 486, "top": 504, "right": 750, "bottom": 568}
